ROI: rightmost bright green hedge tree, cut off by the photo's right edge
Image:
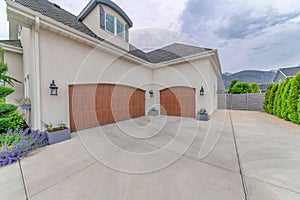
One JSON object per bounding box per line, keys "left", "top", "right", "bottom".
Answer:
{"left": 287, "top": 73, "right": 300, "bottom": 123}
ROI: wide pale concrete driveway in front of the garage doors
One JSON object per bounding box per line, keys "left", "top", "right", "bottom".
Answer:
{"left": 0, "top": 110, "right": 300, "bottom": 200}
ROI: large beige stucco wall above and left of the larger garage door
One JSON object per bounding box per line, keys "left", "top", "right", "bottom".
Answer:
{"left": 40, "top": 29, "right": 152, "bottom": 127}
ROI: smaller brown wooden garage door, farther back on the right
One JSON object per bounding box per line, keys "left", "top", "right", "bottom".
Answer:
{"left": 160, "top": 87, "right": 196, "bottom": 117}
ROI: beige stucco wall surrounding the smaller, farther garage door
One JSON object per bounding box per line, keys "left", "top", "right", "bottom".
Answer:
{"left": 153, "top": 58, "right": 218, "bottom": 116}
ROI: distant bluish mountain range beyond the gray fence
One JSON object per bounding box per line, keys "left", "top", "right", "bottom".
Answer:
{"left": 222, "top": 70, "right": 276, "bottom": 89}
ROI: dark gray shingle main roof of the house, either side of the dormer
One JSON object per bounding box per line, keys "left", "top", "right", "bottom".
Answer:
{"left": 15, "top": 0, "right": 211, "bottom": 63}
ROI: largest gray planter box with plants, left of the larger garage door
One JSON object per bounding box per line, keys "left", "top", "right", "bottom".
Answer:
{"left": 42, "top": 122, "right": 71, "bottom": 145}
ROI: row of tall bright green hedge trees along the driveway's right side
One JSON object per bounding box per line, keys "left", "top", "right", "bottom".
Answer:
{"left": 263, "top": 73, "right": 300, "bottom": 124}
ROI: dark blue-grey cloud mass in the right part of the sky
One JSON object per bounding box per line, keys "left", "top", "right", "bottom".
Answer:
{"left": 180, "top": 0, "right": 300, "bottom": 71}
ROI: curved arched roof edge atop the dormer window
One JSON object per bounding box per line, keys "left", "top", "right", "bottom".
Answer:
{"left": 77, "top": 0, "right": 133, "bottom": 28}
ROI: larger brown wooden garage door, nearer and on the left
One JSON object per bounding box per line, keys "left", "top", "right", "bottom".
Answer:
{"left": 69, "top": 84, "right": 145, "bottom": 131}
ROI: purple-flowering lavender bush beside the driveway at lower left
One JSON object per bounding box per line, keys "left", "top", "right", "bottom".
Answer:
{"left": 0, "top": 128, "right": 48, "bottom": 167}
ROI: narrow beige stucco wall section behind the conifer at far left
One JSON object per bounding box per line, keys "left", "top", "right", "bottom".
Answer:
{"left": 4, "top": 51, "right": 24, "bottom": 104}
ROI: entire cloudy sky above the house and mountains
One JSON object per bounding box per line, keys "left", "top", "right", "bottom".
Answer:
{"left": 0, "top": 0, "right": 300, "bottom": 72}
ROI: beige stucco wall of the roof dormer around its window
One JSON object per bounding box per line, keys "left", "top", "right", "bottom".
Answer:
{"left": 82, "top": 5, "right": 129, "bottom": 51}
